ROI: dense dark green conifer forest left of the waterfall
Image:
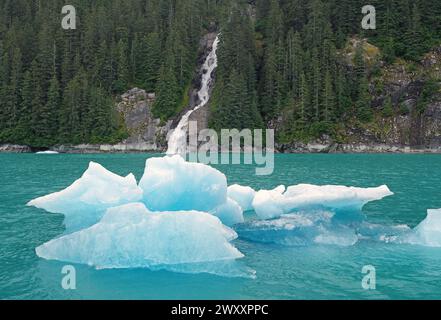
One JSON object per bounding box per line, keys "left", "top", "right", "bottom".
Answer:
{"left": 0, "top": 0, "right": 216, "bottom": 147}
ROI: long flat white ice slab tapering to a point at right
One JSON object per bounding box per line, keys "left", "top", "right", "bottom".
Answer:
{"left": 253, "top": 184, "right": 393, "bottom": 219}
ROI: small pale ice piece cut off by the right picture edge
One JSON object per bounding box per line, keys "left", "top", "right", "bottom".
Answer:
{"left": 399, "top": 209, "right": 441, "bottom": 247}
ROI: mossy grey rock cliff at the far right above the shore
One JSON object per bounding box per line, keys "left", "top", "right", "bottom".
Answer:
{"left": 355, "top": 47, "right": 441, "bottom": 150}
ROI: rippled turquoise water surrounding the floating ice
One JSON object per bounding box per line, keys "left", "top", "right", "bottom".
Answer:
{"left": 0, "top": 154, "right": 441, "bottom": 299}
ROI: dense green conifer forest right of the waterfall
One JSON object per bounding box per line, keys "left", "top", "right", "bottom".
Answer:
{"left": 212, "top": 0, "right": 441, "bottom": 141}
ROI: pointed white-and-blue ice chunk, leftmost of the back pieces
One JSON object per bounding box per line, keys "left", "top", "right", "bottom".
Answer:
{"left": 28, "top": 162, "right": 142, "bottom": 232}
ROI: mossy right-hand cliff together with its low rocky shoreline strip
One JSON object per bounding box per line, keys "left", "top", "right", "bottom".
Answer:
{"left": 276, "top": 44, "right": 441, "bottom": 153}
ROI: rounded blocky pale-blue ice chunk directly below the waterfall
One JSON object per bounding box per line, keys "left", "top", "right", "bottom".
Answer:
{"left": 139, "top": 155, "right": 227, "bottom": 212}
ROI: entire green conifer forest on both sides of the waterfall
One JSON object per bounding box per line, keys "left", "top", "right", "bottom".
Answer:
{"left": 0, "top": 0, "right": 441, "bottom": 147}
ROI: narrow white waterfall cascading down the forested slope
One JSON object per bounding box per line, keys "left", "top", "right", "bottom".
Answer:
{"left": 167, "top": 36, "right": 219, "bottom": 156}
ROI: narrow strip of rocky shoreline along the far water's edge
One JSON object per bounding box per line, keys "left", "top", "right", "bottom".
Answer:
{"left": 0, "top": 143, "right": 441, "bottom": 154}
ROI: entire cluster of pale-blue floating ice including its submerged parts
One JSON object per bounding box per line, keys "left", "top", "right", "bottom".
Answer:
{"left": 28, "top": 155, "right": 441, "bottom": 277}
